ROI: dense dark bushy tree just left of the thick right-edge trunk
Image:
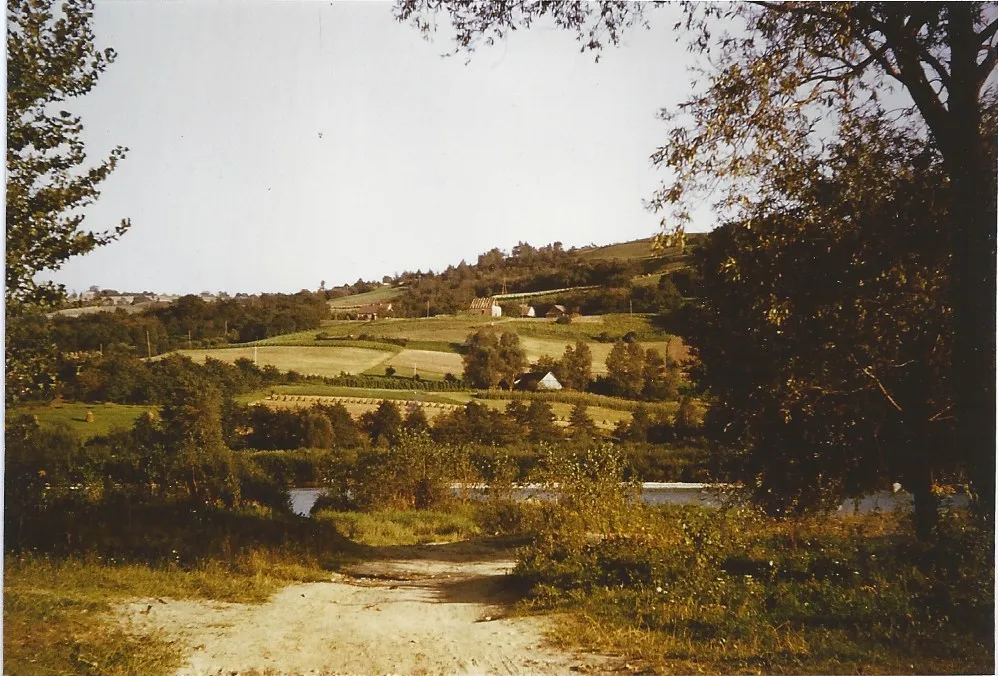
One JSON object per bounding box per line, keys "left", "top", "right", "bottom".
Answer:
{"left": 677, "top": 123, "right": 952, "bottom": 524}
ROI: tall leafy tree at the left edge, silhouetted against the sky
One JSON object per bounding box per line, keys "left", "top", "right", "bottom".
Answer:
{"left": 5, "top": 0, "right": 129, "bottom": 312}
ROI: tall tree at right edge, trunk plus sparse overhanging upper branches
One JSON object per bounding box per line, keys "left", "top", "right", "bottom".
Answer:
{"left": 397, "top": 0, "right": 998, "bottom": 514}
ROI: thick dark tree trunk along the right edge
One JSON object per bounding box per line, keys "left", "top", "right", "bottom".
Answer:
{"left": 939, "top": 3, "right": 996, "bottom": 520}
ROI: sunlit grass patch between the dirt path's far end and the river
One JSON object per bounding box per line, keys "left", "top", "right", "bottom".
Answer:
{"left": 313, "top": 504, "right": 480, "bottom": 547}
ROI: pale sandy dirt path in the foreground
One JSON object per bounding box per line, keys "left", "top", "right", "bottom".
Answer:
{"left": 117, "top": 558, "right": 617, "bottom": 676}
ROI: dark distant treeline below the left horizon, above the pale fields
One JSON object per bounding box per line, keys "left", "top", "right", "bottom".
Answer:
{"left": 41, "top": 291, "right": 329, "bottom": 356}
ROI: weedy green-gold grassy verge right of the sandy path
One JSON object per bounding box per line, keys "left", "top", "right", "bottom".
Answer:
{"left": 516, "top": 501, "right": 994, "bottom": 674}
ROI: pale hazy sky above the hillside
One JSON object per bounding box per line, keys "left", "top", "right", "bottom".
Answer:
{"left": 40, "top": 0, "right": 713, "bottom": 293}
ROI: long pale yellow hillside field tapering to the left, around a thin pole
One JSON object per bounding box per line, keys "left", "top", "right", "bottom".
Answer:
{"left": 178, "top": 346, "right": 391, "bottom": 376}
